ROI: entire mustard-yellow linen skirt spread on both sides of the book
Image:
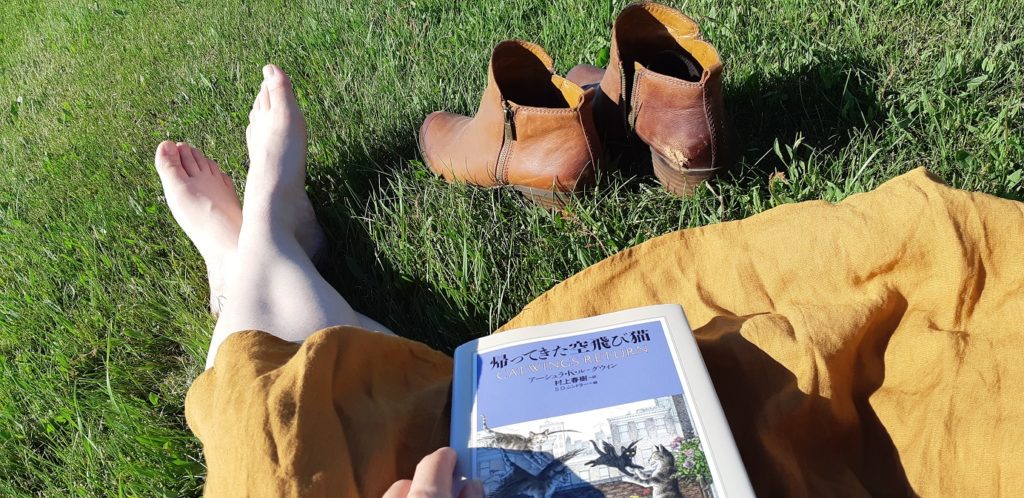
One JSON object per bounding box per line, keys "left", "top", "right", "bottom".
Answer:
{"left": 186, "top": 170, "right": 1024, "bottom": 496}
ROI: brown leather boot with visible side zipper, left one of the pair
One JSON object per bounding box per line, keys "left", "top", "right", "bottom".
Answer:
{"left": 419, "top": 40, "right": 600, "bottom": 208}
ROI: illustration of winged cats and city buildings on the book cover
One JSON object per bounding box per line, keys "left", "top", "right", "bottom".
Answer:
{"left": 474, "top": 395, "right": 715, "bottom": 498}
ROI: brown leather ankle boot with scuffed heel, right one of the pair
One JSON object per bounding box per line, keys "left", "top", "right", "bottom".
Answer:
{"left": 567, "top": 2, "right": 731, "bottom": 196}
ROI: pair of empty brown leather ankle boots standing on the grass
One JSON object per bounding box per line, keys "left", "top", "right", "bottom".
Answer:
{"left": 419, "top": 2, "right": 727, "bottom": 207}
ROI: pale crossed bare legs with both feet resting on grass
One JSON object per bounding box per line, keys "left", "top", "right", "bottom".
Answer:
{"left": 156, "top": 65, "right": 390, "bottom": 368}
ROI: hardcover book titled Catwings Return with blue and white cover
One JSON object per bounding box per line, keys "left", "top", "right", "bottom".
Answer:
{"left": 451, "top": 304, "right": 754, "bottom": 498}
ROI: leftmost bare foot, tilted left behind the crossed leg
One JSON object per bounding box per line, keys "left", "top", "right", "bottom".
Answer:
{"left": 155, "top": 140, "right": 242, "bottom": 315}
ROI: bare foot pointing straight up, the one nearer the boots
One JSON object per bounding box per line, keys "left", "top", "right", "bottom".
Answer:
{"left": 245, "top": 65, "right": 325, "bottom": 258}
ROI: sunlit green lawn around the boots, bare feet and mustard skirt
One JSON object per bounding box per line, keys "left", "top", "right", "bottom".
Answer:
{"left": 0, "top": 0, "right": 1024, "bottom": 496}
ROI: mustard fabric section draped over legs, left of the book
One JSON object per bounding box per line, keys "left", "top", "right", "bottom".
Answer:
{"left": 185, "top": 327, "right": 452, "bottom": 497}
